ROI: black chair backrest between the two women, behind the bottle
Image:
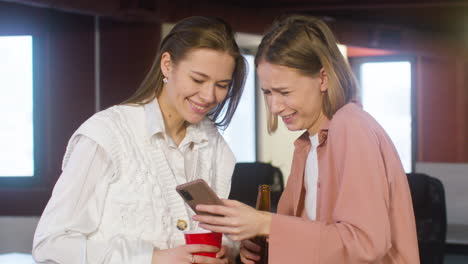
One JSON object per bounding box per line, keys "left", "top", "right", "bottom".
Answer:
{"left": 229, "top": 162, "right": 284, "bottom": 212}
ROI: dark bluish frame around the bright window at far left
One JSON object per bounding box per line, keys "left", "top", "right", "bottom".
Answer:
{"left": 0, "top": 15, "right": 52, "bottom": 216}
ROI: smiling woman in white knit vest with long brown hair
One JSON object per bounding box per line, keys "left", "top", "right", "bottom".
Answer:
{"left": 33, "top": 17, "right": 246, "bottom": 264}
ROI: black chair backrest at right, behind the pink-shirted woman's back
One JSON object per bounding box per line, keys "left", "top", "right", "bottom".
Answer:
{"left": 407, "top": 173, "right": 447, "bottom": 264}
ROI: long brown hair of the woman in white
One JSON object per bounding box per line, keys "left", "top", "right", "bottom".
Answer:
{"left": 123, "top": 16, "right": 247, "bottom": 128}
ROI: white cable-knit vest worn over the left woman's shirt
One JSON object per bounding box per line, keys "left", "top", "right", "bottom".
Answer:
{"left": 63, "top": 103, "right": 232, "bottom": 249}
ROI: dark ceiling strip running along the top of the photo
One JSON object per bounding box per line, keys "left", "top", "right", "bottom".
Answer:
{"left": 0, "top": 0, "right": 468, "bottom": 43}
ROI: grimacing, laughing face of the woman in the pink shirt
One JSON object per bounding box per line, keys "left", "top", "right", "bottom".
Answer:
{"left": 257, "top": 61, "right": 328, "bottom": 135}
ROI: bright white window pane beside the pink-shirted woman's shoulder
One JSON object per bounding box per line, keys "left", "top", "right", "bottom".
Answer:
{"left": 361, "top": 61, "right": 412, "bottom": 172}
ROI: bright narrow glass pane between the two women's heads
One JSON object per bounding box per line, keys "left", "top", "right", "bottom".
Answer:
{"left": 221, "top": 55, "right": 256, "bottom": 162}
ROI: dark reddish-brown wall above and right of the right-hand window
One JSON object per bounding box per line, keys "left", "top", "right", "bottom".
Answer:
{"left": 332, "top": 22, "right": 468, "bottom": 163}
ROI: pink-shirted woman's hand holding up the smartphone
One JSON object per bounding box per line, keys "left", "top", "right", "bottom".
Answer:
{"left": 193, "top": 200, "right": 272, "bottom": 241}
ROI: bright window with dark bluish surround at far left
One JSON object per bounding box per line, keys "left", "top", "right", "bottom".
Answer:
{"left": 0, "top": 23, "right": 48, "bottom": 216}
